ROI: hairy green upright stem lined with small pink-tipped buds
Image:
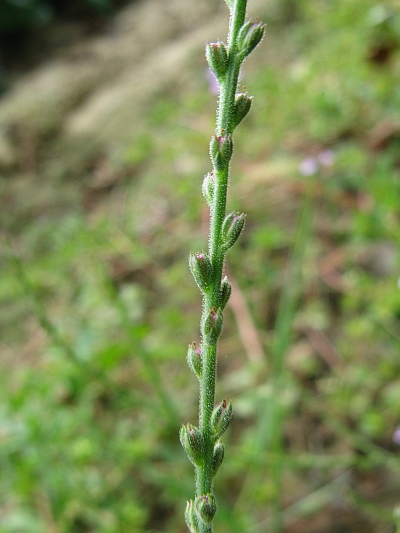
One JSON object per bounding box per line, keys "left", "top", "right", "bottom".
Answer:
{"left": 180, "top": 0, "right": 265, "bottom": 533}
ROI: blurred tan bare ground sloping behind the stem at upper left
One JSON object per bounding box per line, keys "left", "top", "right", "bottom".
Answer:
{"left": 0, "top": 0, "right": 263, "bottom": 174}
